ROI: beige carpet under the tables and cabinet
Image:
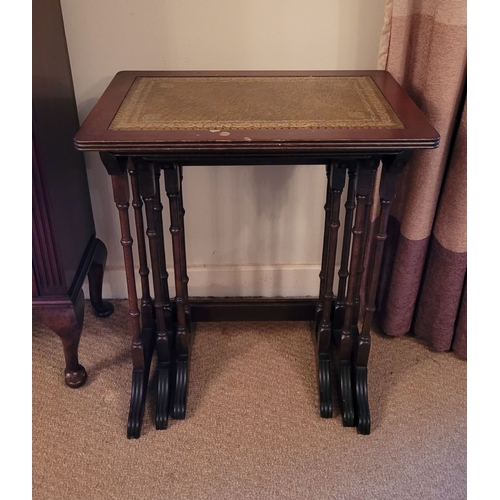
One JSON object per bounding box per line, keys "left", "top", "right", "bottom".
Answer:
{"left": 32, "top": 301, "right": 467, "bottom": 500}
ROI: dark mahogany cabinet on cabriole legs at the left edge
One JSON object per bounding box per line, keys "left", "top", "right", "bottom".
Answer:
{"left": 32, "top": 0, "right": 113, "bottom": 387}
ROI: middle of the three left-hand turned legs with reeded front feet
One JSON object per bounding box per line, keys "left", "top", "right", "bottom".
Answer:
{"left": 137, "top": 160, "right": 174, "bottom": 429}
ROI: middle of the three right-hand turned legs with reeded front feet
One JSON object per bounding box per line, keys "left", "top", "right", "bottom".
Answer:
{"left": 338, "top": 166, "right": 373, "bottom": 426}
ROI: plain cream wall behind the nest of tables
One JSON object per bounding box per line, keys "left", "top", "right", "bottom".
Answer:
{"left": 61, "top": 0, "right": 384, "bottom": 298}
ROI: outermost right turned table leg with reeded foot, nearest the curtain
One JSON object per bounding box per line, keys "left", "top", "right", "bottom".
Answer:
{"left": 353, "top": 152, "right": 410, "bottom": 434}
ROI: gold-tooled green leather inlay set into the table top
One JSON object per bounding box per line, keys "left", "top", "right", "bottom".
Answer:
{"left": 109, "top": 76, "right": 404, "bottom": 130}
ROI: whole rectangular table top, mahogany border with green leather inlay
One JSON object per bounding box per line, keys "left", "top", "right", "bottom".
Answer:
{"left": 75, "top": 71, "right": 439, "bottom": 154}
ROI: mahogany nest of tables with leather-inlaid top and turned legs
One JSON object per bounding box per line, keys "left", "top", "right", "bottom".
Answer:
{"left": 75, "top": 71, "right": 439, "bottom": 437}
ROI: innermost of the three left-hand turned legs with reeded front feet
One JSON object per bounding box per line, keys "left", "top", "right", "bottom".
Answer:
{"left": 165, "top": 164, "right": 191, "bottom": 419}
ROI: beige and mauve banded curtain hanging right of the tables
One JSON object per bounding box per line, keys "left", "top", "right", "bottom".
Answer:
{"left": 378, "top": 0, "right": 467, "bottom": 359}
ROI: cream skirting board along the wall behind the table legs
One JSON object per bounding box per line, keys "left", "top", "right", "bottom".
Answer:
{"left": 83, "top": 264, "right": 339, "bottom": 299}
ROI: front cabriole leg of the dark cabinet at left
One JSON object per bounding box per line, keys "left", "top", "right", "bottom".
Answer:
{"left": 38, "top": 290, "right": 87, "bottom": 388}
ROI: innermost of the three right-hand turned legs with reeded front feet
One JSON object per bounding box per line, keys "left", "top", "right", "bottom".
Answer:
{"left": 316, "top": 162, "right": 345, "bottom": 418}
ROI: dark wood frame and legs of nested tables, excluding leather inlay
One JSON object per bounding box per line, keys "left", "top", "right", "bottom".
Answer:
{"left": 75, "top": 71, "right": 439, "bottom": 438}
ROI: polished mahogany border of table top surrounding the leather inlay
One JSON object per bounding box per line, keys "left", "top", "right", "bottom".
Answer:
{"left": 75, "top": 71, "right": 439, "bottom": 156}
